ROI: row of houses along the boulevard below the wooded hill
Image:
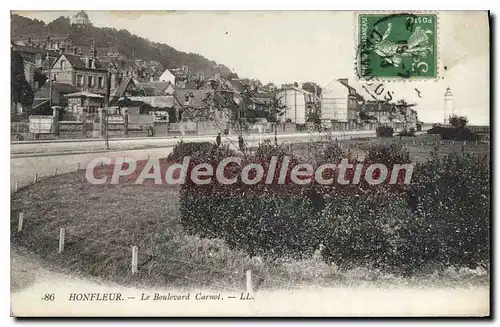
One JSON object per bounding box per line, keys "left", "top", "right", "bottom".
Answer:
{"left": 11, "top": 13, "right": 418, "bottom": 129}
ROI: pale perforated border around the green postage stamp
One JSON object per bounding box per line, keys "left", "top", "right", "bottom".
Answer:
{"left": 352, "top": 10, "right": 443, "bottom": 83}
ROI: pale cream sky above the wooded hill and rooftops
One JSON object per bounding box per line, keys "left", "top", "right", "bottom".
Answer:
{"left": 16, "top": 11, "right": 490, "bottom": 124}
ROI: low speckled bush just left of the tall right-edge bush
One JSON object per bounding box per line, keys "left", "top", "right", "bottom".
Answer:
{"left": 323, "top": 192, "right": 425, "bottom": 272}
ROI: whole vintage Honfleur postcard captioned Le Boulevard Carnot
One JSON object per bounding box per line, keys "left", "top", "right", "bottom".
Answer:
{"left": 10, "top": 10, "right": 492, "bottom": 317}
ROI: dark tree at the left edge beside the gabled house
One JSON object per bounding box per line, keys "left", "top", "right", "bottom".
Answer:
{"left": 10, "top": 51, "right": 34, "bottom": 106}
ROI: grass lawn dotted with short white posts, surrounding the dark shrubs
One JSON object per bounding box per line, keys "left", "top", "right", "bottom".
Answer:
{"left": 11, "top": 137, "right": 489, "bottom": 290}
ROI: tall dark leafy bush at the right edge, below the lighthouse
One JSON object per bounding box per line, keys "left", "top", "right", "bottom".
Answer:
{"left": 408, "top": 152, "right": 491, "bottom": 266}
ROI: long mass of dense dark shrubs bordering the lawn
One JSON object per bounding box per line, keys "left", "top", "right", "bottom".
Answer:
{"left": 174, "top": 140, "right": 490, "bottom": 273}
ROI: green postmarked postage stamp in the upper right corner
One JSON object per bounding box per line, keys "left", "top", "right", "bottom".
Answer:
{"left": 356, "top": 13, "right": 438, "bottom": 80}
